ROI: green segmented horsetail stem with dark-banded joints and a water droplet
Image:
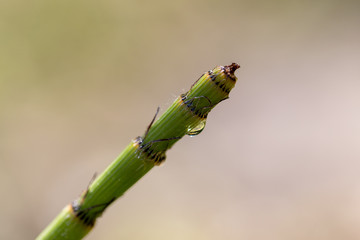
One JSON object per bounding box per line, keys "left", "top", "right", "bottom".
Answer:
{"left": 37, "top": 63, "right": 240, "bottom": 239}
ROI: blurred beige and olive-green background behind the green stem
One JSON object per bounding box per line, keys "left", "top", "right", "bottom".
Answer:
{"left": 0, "top": 0, "right": 360, "bottom": 240}
